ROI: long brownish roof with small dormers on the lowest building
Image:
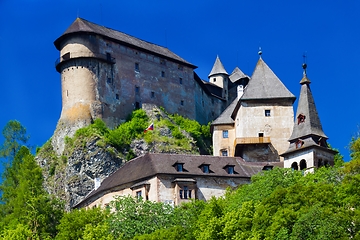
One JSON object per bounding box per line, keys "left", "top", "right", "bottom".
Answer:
{"left": 74, "top": 153, "right": 276, "bottom": 207}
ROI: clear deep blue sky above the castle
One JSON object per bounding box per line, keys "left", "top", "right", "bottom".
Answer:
{"left": 0, "top": 0, "right": 360, "bottom": 173}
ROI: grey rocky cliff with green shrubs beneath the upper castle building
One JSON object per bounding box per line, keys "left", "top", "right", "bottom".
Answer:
{"left": 36, "top": 105, "right": 211, "bottom": 209}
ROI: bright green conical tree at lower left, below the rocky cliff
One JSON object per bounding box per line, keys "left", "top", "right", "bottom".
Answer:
{"left": 0, "top": 146, "right": 62, "bottom": 239}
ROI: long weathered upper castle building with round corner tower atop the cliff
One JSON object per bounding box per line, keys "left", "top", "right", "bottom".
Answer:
{"left": 53, "top": 18, "right": 233, "bottom": 154}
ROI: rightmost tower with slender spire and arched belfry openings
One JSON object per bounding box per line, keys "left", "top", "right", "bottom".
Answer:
{"left": 282, "top": 64, "right": 336, "bottom": 171}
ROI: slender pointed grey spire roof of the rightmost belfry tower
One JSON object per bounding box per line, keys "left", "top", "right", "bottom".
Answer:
{"left": 289, "top": 65, "right": 327, "bottom": 142}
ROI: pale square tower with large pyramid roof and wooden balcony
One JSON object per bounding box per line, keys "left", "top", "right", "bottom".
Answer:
{"left": 212, "top": 57, "right": 295, "bottom": 161}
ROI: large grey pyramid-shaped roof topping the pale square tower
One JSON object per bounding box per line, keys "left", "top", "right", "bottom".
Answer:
{"left": 241, "top": 57, "right": 295, "bottom": 101}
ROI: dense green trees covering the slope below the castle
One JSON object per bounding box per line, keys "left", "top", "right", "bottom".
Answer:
{"left": 0, "top": 119, "right": 360, "bottom": 240}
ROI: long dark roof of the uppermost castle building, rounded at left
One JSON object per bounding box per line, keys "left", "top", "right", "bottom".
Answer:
{"left": 54, "top": 18, "right": 197, "bottom": 69}
